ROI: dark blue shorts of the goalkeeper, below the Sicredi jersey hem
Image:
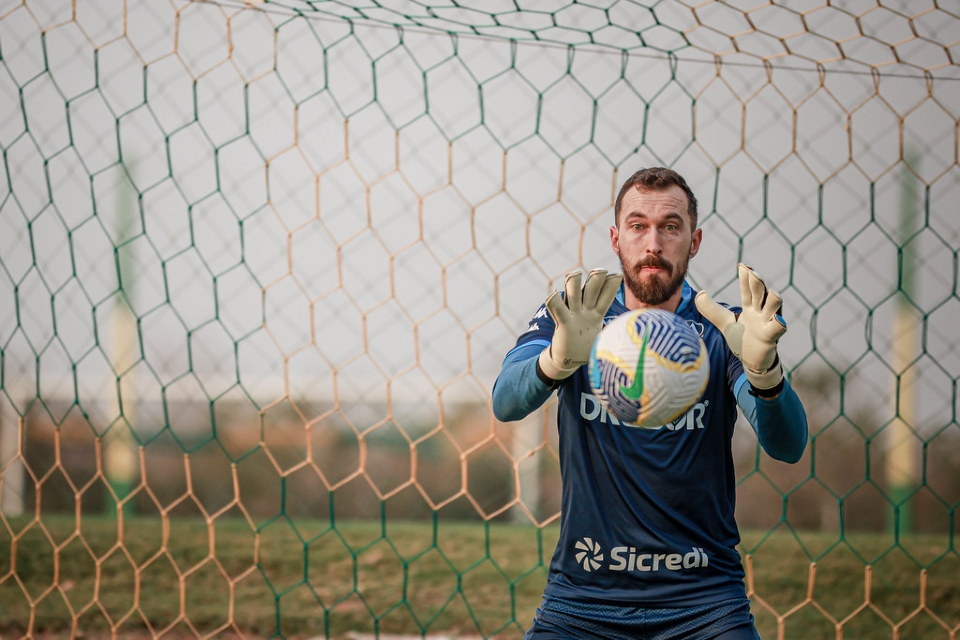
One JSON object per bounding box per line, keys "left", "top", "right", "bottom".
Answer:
{"left": 525, "top": 596, "right": 760, "bottom": 640}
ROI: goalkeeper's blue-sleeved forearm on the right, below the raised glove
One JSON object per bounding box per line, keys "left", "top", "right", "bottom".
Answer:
{"left": 736, "top": 376, "right": 807, "bottom": 464}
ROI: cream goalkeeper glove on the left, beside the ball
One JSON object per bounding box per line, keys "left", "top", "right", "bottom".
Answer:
{"left": 538, "top": 269, "right": 623, "bottom": 380}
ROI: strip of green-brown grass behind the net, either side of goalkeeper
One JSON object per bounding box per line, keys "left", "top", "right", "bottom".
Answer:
{"left": 0, "top": 514, "right": 960, "bottom": 640}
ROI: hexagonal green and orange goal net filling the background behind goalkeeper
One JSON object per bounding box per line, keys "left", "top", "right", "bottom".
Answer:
{"left": 0, "top": 0, "right": 960, "bottom": 638}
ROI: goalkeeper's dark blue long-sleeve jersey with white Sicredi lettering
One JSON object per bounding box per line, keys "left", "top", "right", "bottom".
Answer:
{"left": 493, "top": 283, "right": 807, "bottom": 607}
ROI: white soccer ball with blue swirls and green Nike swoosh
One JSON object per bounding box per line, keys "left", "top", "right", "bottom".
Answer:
{"left": 588, "top": 308, "right": 710, "bottom": 428}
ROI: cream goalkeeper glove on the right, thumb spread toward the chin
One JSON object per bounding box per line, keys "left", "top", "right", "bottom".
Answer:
{"left": 695, "top": 264, "right": 787, "bottom": 390}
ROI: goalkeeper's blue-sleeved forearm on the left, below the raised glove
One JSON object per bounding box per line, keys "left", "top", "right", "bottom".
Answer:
{"left": 493, "top": 341, "right": 553, "bottom": 422}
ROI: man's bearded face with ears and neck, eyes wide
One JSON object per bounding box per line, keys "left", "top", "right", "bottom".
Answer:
{"left": 610, "top": 185, "right": 702, "bottom": 311}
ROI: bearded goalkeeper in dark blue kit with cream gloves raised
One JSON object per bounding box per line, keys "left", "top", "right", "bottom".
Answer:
{"left": 493, "top": 168, "right": 807, "bottom": 640}
